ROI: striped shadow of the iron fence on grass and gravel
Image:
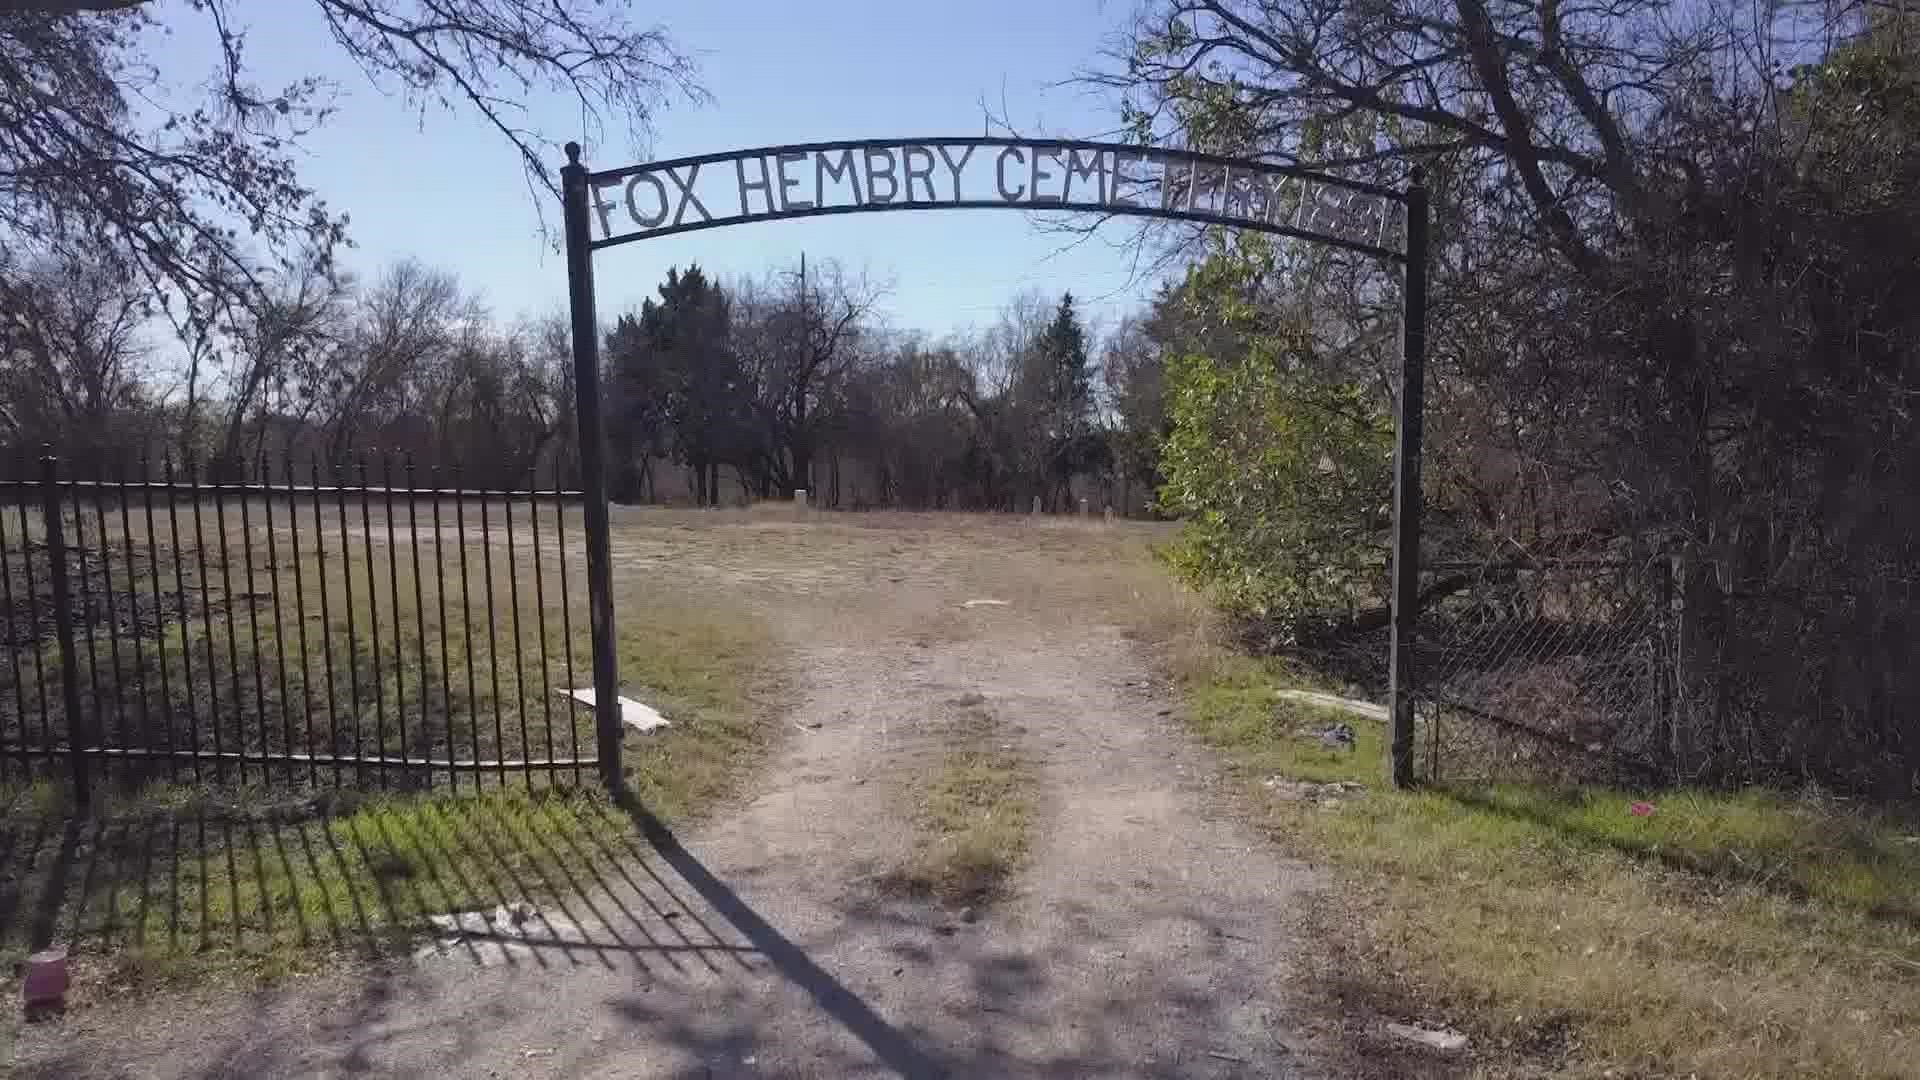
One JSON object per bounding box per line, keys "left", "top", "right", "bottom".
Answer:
{"left": 0, "top": 780, "right": 756, "bottom": 999}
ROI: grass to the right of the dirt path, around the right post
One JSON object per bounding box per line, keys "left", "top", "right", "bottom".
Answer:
{"left": 1185, "top": 645, "right": 1920, "bottom": 1078}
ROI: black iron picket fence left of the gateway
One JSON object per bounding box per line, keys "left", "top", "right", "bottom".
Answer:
{"left": 0, "top": 447, "right": 597, "bottom": 799}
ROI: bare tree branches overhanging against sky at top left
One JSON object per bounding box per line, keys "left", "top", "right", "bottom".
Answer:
{"left": 0, "top": 0, "right": 701, "bottom": 336}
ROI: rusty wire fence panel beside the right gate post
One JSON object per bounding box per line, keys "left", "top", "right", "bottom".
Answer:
{"left": 1413, "top": 555, "right": 1678, "bottom": 782}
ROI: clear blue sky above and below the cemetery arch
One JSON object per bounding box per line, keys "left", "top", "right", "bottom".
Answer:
{"left": 149, "top": 0, "right": 1146, "bottom": 336}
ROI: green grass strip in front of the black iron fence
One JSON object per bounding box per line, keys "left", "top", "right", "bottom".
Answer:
{"left": 0, "top": 786, "right": 630, "bottom": 997}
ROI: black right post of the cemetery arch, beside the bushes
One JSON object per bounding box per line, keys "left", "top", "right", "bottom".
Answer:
{"left": 1386, "top": 167, "right": 1427, "bottom": 788}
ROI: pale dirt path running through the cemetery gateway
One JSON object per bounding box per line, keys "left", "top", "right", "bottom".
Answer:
{"left": 23, "top": 513, "right": 1344, "bottom": 1076}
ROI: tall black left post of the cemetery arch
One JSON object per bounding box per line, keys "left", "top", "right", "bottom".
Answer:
{"left": 561, "top": 142, "right": 626, "bottom": 796}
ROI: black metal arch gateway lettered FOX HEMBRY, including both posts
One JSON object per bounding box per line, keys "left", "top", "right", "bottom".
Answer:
{"left": 561, "top": 136, "right": 1428, "bottom": 794}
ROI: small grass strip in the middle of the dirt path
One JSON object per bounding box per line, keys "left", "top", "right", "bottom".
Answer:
{"left": 887, "top": 713, "right": 1033, "bottom": 907}
